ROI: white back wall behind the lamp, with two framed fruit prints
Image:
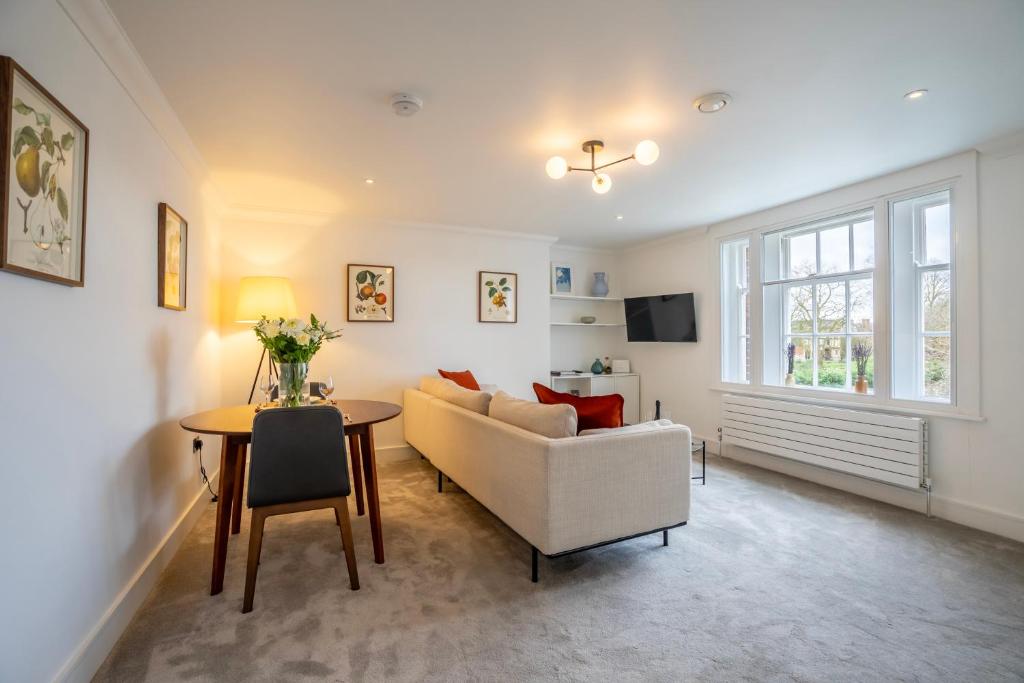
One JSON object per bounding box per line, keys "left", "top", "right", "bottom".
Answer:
{"left": 221, "top": 218, "right": 550, "bottom": 452}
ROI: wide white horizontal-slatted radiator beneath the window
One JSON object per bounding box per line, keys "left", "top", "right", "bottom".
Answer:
{"left": 722, "top": 395, "right": 930, "bottom": 489}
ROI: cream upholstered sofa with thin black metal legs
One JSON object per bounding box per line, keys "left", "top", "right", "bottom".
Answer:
{"left": 404, "top": 382, "right": 690, "bottom": 582}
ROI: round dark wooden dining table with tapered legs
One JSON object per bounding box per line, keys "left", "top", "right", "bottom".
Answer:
{"left": 178, "top": 399, "right": 401, "bottom": 595}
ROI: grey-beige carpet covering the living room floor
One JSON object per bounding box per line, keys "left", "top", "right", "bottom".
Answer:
{"left": 96, "top": 450, "right": 1024, "bottom": 681}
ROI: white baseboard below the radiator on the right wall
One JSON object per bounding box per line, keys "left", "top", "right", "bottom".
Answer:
{"left": 709, "top": 445, "right": 1024, "bottom": 542}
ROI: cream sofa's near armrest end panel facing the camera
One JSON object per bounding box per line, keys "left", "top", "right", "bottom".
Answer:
{"left": 541, "top": 425, "right": 691, "bottom": 555}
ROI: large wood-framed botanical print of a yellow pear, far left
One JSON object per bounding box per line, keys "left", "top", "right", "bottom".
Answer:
{"left": 0, "top": 57, "right": 89, "bottom": 287}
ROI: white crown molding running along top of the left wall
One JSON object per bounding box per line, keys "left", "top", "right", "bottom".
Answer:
{"left": 57, "top": 0, "right": 208, "bottom": 181}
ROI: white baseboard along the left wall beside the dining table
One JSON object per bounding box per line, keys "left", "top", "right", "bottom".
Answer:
{"left": 53, "top": 471, "right": 220, "bottom": 683}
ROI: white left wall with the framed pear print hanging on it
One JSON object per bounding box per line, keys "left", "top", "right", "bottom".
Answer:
{"left": 0, "top": 0, "right": 220, "bottom": 681}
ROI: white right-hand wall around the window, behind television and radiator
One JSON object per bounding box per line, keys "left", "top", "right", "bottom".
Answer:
{"left": 624, "top": 145, "right": 1024, "bottom": 541}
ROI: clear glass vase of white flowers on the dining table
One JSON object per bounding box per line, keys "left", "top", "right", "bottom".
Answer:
{"left": 253, "top": 315, "right": 341, "bottom": 407}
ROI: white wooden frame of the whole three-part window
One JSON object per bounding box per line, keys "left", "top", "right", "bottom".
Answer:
{"left": 708, "top": 151, "right": 983, "bottom": 421}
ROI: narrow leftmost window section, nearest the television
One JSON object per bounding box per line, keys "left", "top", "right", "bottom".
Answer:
{"left": 720, "top": 239, "right": 751, "bottom": 383}
